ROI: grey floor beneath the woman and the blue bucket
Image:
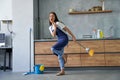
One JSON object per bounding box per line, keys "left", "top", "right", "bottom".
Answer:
{"left": 0, "top": 70, "right": 120, "bottom": 80}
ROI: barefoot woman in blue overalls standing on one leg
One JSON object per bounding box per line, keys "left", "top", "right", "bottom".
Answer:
{"left": 49, "top": 12, "right": 76, "bottom": 76}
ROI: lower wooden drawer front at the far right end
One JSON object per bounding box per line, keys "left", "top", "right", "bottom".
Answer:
{"left": 105, "top": 53, "right": 120, "bottom": 66}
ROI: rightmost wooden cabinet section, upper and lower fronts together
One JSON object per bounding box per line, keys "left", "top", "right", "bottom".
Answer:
{"left": 105, "top": 40, "right": 120, "bottom": 66}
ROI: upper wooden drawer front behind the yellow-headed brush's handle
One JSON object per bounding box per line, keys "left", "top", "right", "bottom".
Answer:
{"left": 79, "top": 40, "right": 104, "bottom": 53}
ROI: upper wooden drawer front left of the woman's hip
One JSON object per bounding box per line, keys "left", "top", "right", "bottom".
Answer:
{"left": 35, "top": 42, "right": 55, "bottom": 54}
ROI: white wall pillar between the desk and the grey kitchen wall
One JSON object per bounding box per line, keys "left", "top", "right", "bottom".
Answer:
{"left": 12, "top": 0, "right": 34, "bottom": 72}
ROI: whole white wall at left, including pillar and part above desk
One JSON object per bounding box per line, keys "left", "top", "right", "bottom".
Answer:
{"left": 0, "top": 0, "right": 34, "bottom": 72}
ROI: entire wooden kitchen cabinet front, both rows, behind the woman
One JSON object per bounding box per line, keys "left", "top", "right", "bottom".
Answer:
{"left": 34, "top": 39, "right": 120, "bottom": 67}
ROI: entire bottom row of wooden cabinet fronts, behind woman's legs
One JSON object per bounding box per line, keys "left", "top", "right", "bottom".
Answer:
{"left": 35, "top": 53, "right": 120, "bottom": 67}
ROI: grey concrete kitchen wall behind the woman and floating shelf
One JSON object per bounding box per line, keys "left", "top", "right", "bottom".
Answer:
{"left": 35, "top": 0, "right": 120, "bottom": 39}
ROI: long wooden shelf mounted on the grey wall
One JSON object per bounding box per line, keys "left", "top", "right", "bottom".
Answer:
{"left": 69, "top": 10, "right": 112, "bottom": 14}
